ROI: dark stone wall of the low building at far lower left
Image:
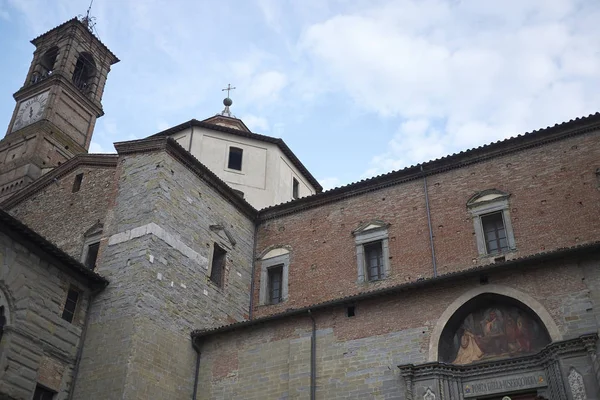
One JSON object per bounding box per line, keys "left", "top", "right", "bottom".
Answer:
{"left": 0, "top": 228, "right": 89, "bottom": 400}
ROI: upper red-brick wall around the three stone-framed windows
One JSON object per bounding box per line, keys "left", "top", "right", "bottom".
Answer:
{"left": 254, "top": 131, "right": 600, "bottom": 316}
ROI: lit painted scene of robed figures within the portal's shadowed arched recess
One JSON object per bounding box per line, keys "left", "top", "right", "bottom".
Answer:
{"left": 451, "top": 306, "right": 549, "bottom": 365}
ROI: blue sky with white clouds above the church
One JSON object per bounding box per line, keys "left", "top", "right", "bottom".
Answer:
{"left": 0, "top": 0, "right": 600, "bottom": 189}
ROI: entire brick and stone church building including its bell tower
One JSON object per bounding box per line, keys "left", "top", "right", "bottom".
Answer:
{"left": 0, "top": 19, "right": 600, "bottom": 400}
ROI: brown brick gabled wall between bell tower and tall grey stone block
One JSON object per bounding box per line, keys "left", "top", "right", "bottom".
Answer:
{"left": 9, "top": 166, "right": 115, "bottom": 260}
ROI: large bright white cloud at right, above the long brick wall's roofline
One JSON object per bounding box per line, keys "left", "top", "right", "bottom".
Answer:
{"left": 300, "top": 0, "right": 600, "bottom": 176}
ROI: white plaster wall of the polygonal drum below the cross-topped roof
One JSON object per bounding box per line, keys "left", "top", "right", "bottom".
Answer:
{"left": 171, "top": 127, "right": 315, "bottom": 209}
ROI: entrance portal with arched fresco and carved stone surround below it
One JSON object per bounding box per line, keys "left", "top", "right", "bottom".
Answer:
{"left": 399, "top": 293, "right": 600, "bottom": 400}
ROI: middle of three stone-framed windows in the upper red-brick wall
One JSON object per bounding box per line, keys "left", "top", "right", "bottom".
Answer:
{"left": 352, "top": 220, "right": 390, "bottom": 283}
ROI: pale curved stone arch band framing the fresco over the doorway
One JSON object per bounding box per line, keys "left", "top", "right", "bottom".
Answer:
{"left": 427, "top": 284, "right": 563, "bottom": 362}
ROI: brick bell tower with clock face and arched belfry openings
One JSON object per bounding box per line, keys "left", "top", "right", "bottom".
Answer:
{"left": 0, "top": 15, "right": 119, "bottom": 202}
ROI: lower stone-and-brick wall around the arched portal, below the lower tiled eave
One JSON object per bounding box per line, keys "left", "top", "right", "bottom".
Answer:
{"left": 199, "top": 257, "right": 600, "bottom": 400}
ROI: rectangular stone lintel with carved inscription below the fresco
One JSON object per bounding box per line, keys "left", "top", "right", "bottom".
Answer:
{"left": 463, "top": 371, "right": 548, "bottom": 398}
